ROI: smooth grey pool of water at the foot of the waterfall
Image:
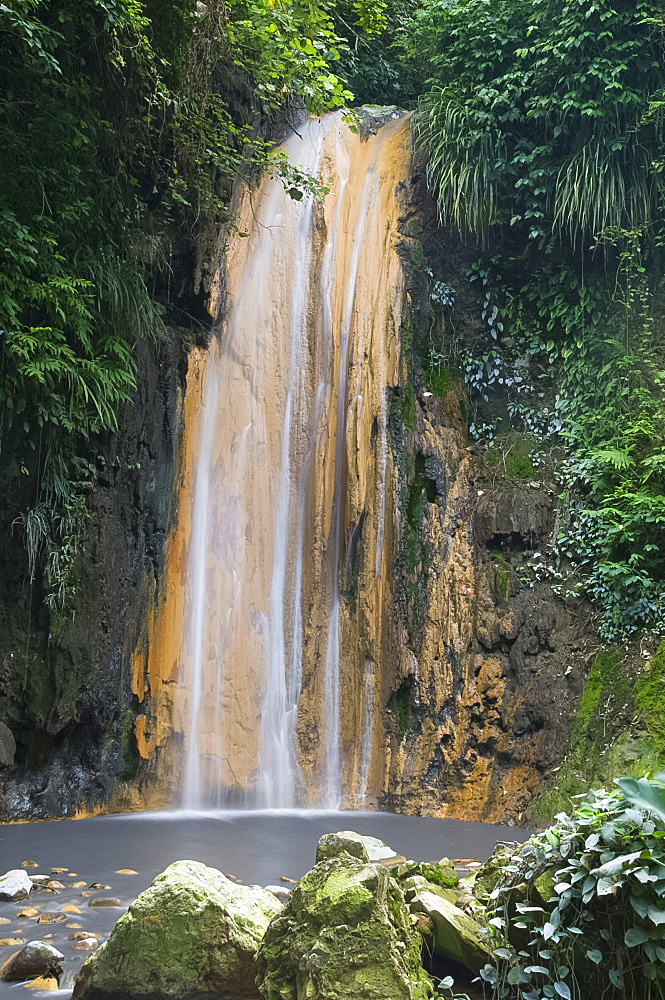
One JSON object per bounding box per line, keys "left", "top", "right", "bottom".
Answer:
{"left": 0, "top": 811, "right": 528, "bottom": 1000}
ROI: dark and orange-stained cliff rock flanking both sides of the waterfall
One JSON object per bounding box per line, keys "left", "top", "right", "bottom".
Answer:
{"left": 0, "top": 117, "right": 662, "bottom": 822}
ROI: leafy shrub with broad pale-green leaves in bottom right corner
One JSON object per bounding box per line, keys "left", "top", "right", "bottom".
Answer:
{"left": 482, "top": 775, "right": 665, "bottom": 1000}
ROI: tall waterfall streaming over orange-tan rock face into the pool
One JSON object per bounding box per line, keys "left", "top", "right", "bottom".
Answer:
{"left": 132, "top": 114, "right": 409, "bottom": 808}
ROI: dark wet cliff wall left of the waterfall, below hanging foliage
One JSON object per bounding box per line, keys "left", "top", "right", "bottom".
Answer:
{"left": 0, "top": 328, "right": 193, "bottom": 818}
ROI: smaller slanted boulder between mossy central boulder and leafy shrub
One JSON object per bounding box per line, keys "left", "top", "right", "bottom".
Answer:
{"left": 409, "top": 889, "right": 492, "bottom": 975}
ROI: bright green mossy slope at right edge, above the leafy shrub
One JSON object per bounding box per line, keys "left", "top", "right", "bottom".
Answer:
{"left": 526, "top": 643, "right": 665, "bottom": 823}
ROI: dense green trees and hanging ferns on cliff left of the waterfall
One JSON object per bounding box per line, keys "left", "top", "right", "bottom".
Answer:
{"left": 0, "top": 0, "right": 383, "bottom": 607}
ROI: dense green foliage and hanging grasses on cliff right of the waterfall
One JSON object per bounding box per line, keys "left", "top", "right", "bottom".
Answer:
{"left": 413, "top": 0, "right": 665, "bottom": 638}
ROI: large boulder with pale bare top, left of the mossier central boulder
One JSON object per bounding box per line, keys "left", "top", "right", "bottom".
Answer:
{"left": 73, "top": 861, "right": 282, "bottom": 1000}
